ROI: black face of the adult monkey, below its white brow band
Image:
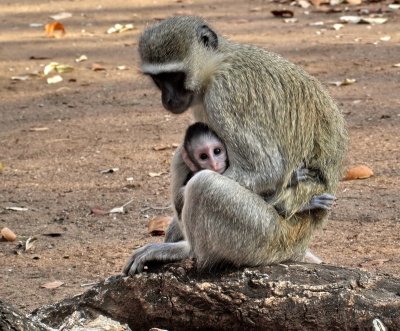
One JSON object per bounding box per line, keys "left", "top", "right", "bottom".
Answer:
{"left": 150, "top": 72, "right": 194, "bottom": 114}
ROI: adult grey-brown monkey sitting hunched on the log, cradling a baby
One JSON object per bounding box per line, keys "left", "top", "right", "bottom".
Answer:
{"left": 123, "top": 17, "right": 347, "bottom": 274}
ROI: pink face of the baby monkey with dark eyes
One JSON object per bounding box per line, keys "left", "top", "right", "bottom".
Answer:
{"left": 193, "top": 137, "right": 228, "bottom": 174}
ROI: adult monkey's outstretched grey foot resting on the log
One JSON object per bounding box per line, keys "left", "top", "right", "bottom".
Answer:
{"left": 122, "top": 241, "right": 190, "bottom": 276}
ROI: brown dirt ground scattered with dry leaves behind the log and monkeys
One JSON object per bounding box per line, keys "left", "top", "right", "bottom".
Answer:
{"left": 0, "top": 0, "right": 400, "bottom": 312}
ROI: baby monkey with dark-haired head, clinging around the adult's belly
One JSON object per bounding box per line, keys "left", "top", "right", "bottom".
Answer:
{"left": 181, "top": 122, "right": 335, "bottom": 263}
